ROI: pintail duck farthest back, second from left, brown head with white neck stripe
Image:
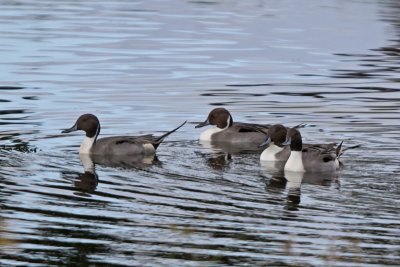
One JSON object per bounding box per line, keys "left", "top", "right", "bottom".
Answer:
{"left": 195, "top": 108, "right": 268, "bottom": 147}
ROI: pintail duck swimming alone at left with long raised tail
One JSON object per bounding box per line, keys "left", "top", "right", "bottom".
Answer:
{"left": 62, "top": 114, "right": 186, "bottom": 156}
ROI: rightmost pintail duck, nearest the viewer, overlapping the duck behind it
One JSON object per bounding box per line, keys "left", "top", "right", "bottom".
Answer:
{"left": 283, "top": 128, "right": 343, "bottom": 173}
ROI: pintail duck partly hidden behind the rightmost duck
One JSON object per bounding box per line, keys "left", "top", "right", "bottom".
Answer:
{"left": 260, "top": 124, "right": 337, "bottom": 162}
